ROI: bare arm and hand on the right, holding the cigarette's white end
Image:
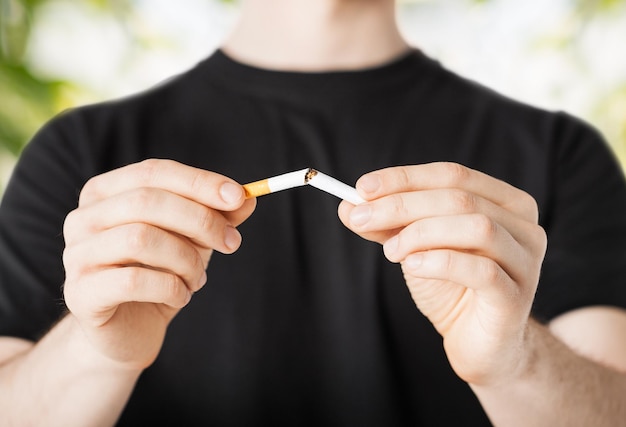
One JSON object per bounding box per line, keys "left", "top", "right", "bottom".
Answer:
{"left": 339, "top": 163, "right": 626, "bottom": 426}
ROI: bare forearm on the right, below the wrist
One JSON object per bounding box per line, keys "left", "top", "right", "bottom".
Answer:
{"left": 472, "top": 321, "right": 626, "bottom": 427}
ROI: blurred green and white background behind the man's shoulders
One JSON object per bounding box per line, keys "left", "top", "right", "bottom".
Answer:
{"left": 0, "top": 0, "right": 626, "bottom": 192}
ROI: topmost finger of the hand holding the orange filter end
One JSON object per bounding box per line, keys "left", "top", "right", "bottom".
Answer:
{"left": 79, "top": 159, "right": 245, "bottom": 211}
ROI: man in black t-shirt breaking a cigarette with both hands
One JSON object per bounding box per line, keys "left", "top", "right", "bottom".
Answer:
{"left": 0, "top": 0, "right": 626, "bottom": 426}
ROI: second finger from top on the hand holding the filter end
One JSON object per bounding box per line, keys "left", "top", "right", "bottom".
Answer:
{"left": 64, "top": 188, "right": 243, "bottom": 253}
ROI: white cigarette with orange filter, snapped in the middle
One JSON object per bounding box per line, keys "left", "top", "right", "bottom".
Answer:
{"left": 243, "top": 168, "right": 365, "bottom": 205}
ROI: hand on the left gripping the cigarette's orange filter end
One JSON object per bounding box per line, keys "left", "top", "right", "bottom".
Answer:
{"left": 63, "top": 160, "right": 256, "bottom": 369}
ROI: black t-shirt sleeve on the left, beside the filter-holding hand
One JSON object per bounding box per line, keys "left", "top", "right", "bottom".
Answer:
{"left": 0, "top": 113, "right": 84, "bottom": 340}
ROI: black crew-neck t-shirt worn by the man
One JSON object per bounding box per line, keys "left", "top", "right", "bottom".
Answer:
{"left": 0, "top": 51, "right": 626, "bottom": 426}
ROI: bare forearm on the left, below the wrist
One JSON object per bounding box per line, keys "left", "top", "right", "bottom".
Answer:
{"left": 0, "top": 315, "right": 141, "bottom": 426}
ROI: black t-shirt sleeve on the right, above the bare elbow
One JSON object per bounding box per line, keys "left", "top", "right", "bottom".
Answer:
{"left": 533, "top": 114, "right": 626, "bottom": 322}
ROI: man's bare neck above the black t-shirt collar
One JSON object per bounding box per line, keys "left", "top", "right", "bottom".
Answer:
{"left": 223, "top": 0, "right": 409, "bottom": 71}
